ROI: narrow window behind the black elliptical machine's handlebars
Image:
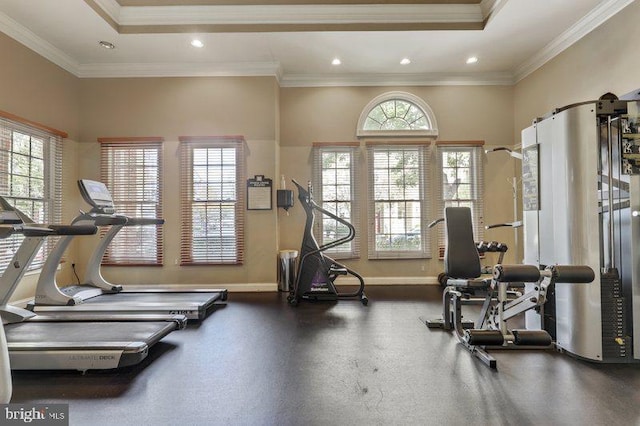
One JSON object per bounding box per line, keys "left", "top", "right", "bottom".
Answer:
{"left": 313, "top": 142, "right": 360, "bottom": 258}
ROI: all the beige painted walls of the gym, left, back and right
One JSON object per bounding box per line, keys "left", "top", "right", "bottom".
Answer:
{"left": 0, "top": 2, "right": 640, "bottom": 298}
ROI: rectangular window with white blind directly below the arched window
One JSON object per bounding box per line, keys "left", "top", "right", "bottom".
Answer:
{"left": 367, "top": 142, "right": 430, "bottom": 259}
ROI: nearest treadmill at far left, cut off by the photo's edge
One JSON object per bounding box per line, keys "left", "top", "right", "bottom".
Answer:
{"left": 0, "top": 197, "right": 186, "bottom": 370}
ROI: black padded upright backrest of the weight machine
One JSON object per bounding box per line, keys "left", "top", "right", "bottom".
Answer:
{"left": 444, "top": 207, "right": 482, "bottom": 279}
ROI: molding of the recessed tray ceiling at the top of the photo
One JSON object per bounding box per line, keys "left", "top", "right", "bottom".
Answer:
{"left": 85, "top": 0, "right": 490, "bottom": 34}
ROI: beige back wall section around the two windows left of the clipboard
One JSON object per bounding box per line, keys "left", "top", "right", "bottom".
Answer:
{"left": 78, "top": 77, "right": 278, "bottom": 286}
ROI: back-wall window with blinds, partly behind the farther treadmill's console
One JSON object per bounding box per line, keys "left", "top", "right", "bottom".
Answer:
{"left": 98, "top": 138, "right": 163, "bottom": 265}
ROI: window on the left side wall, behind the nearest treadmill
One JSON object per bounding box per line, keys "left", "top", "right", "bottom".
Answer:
{"left": 0, "top": 114, "right": 66, "bottom": 270}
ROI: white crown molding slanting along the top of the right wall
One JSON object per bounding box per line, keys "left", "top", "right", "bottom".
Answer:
{"left": 513, "top": 0, "right": 634, "bottom": 83}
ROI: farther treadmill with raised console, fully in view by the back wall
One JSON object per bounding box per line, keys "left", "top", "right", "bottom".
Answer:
{"left": 28, "top": 179, "right": 227, "bottom": 320}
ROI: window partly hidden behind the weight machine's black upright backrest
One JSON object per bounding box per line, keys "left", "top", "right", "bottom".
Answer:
{"left": 437, "top": 141, "right": 484, "bottom": 253}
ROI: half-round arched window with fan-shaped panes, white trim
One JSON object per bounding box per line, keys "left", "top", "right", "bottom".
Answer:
{"left": 356, "top": 92, "right": 438, "bottom": 138}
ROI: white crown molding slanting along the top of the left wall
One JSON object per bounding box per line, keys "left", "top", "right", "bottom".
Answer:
{"left": 0, "top": 13, "right": 78, "bottom": 76}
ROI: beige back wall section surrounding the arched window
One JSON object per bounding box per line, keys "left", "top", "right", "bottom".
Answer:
{"left": 279, "top": 86, "right": 514, "bottom": 281}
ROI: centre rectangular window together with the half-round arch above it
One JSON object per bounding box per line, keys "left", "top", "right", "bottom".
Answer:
{"left": 356, "top": 92, "right": 438, "bottom": 259}
